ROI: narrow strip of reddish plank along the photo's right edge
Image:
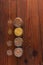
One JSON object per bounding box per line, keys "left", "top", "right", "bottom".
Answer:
{"left": 38, "top": 0, "right": 43, "bottom": 63}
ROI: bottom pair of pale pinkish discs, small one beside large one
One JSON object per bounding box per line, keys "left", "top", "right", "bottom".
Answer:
{"left": 7, "top": 48, "right": 23, "bottom": 58}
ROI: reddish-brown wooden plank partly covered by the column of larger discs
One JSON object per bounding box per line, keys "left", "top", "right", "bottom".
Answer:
{"left": 17, "top": 0, "right": 29, "bottom": 65}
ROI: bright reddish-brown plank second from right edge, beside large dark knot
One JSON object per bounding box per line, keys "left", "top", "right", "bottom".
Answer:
{"left": 30, "top": 0, "right": 41, "bottom": 65}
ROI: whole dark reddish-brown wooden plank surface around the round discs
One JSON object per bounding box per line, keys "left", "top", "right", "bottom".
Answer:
{"left": 0, "top": 0, "right": 43, "bottom": 65}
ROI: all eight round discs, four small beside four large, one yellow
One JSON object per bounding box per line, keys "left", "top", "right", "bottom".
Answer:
{"left": 7, "top": 17, "right": 23, "bottom": 57}
